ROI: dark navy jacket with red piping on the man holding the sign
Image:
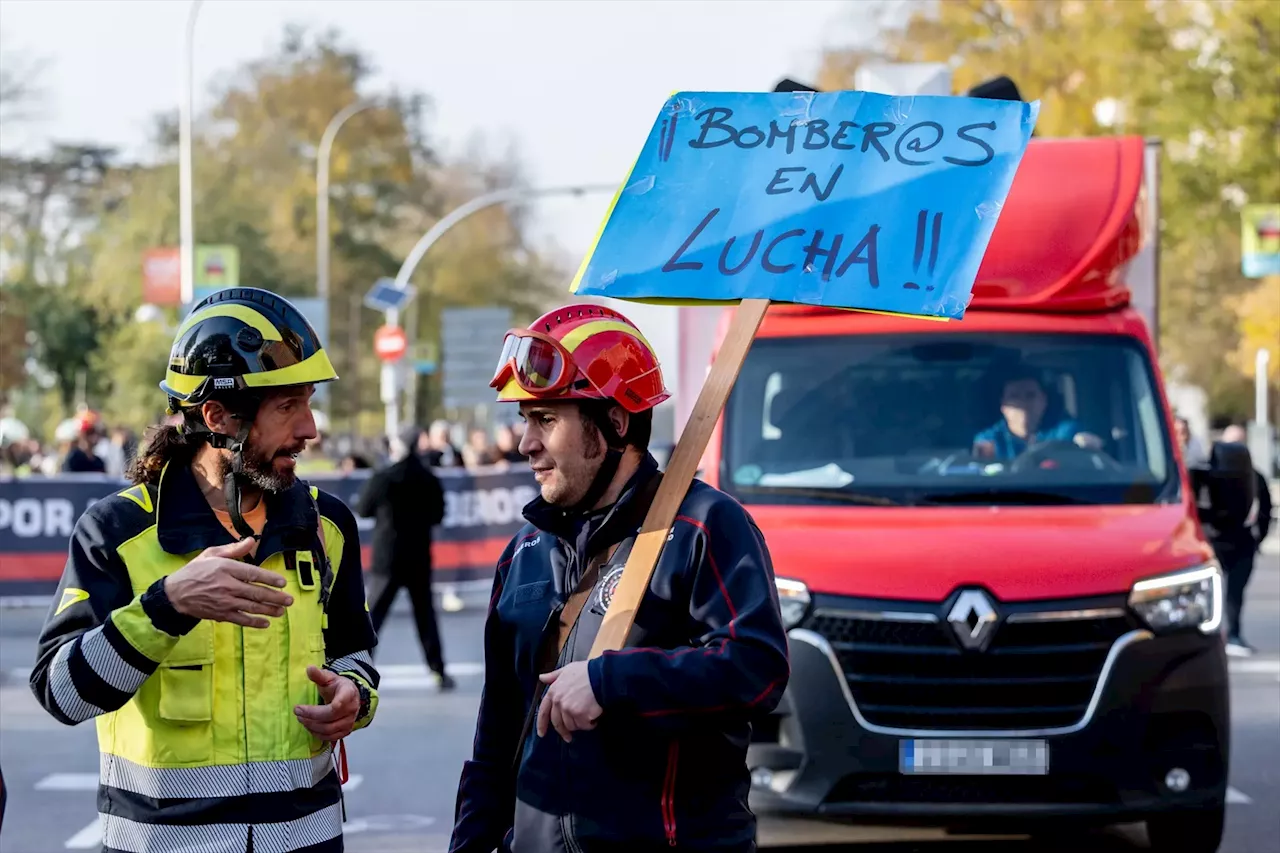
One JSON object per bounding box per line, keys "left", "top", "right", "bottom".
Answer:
{"left": 449, "top": 457, "right": 790, "bottom": 853}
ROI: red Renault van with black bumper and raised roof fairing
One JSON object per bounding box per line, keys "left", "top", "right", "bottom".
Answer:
{"left": 703, "top": 137, "right": 1230, "bottom": 853}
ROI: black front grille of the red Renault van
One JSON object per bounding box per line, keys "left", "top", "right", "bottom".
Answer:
{"left": 809, "top": 611, "right": 1132, "bottom": 730}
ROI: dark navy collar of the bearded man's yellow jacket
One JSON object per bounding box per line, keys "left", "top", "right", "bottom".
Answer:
{"left": 156, "top": 465, "right": 319, "bottom": 564}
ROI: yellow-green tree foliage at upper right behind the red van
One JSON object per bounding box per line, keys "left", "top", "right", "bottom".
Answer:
{"left": 818, "top": 0, "right": 1280, "bottom": 418}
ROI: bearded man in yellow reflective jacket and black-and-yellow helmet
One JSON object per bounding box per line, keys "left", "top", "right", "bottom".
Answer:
{"left": 31, "top": 288, "right": 379, "bottom": 853}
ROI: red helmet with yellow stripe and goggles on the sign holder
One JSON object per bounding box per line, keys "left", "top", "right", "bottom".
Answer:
{"left": 489, "top": 305, "right": 671, "bottom": 412}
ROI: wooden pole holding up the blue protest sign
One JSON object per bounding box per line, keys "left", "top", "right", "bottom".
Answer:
{"left": 591, "top": 300, "right": 769, "bottom": 658}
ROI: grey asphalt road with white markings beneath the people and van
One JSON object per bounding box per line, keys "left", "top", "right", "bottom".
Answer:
{"left": 0, "top": 539, "right": 1280, "bottom": 853}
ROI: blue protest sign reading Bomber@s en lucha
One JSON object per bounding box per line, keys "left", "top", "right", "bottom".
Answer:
{"left": 571, "top": 91, "right": 1039, "bottom": 319}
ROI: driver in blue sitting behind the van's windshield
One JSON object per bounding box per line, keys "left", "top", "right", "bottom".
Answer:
{"left": 973, "top": 368, "right": 1102, "bottom": 461}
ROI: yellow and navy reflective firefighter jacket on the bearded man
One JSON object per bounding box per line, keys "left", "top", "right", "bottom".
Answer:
{"left": 31, "top": 466, "right": 379, "bottom": 853}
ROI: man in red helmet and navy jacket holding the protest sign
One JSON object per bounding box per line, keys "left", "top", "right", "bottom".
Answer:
{"left": 449, "top": 305, "right": 790, "bottom": 853}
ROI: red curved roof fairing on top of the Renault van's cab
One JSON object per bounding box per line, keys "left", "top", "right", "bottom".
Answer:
{"left": 970, "top": 136, "right": 1146, "bottom": 311}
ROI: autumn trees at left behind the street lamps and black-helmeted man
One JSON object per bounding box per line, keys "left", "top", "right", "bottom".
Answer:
{"left": 37, "top": 29, "right": 564, "bottom": 438}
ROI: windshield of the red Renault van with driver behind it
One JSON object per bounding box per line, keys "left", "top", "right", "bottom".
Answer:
{"left": 721, "top": 333, "right": 1180, "bottom": 506}
